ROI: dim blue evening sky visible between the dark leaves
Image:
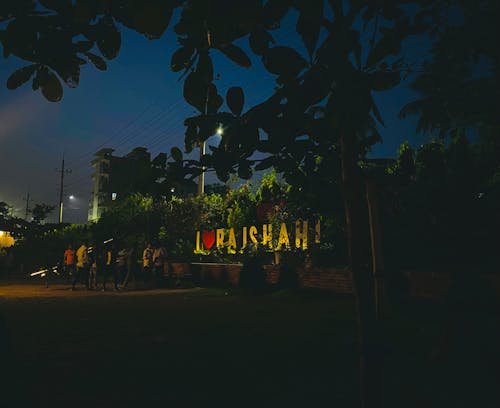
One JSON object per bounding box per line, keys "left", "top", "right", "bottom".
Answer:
{"left": 0, "top": 9, "right": 423, "bottom": 222}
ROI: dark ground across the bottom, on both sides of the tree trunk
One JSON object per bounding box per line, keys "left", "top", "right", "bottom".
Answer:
{"left": 0, "top": 284, "right": 500, "bottom": 407}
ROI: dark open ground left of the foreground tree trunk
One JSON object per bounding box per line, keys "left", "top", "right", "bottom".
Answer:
{"left": 0, "top": 287, "right": 357, "bottom": 407}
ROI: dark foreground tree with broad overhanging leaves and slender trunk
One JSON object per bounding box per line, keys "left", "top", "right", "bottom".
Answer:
{"left": 0, "top": 0, "right": 500, "bottom": 407}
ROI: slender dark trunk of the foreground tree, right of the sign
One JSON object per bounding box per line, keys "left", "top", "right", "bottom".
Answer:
{"left": 340, "top": 133, "right": 382, "bottom": 408}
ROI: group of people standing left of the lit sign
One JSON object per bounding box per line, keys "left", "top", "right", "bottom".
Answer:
{"left": 63, "top": 242, "right": 168, "bottom": 291}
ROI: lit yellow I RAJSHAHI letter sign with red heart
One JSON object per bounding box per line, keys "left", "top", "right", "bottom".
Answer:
{"left": 194, "top": 220, "right": 321, "bottom": 254}
